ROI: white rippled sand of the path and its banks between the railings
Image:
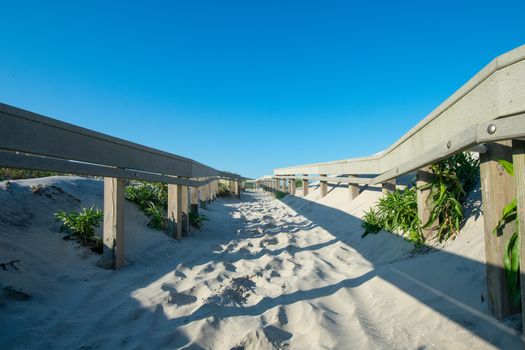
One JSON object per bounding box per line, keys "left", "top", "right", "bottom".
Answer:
{"left": 0, "top": 177, "right": 523, "bottom": 349}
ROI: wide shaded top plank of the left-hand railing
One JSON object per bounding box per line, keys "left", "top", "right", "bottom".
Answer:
{"left": 0, "top": 103, "right": 243, "bottom": 183}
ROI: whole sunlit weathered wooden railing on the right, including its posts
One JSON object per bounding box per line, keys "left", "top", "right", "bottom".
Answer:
{"left": 257, "top": 46, "right": 525, "bottom": 324}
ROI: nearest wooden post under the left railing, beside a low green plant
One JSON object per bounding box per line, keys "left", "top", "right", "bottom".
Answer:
{"left": 103, "top": 177, "right": 125, "bottom": 269}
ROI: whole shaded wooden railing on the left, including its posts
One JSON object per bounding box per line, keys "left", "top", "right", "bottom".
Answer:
{"left": 0, "top": 104, "right": 244, "bottom": 268}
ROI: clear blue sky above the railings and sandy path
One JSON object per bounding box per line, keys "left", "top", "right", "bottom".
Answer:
{"left": 0, "top": 0, "right": 525, "bottom": 177}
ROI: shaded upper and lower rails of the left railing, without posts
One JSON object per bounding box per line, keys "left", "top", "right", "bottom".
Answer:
{"left": 0, "top": 104, "right": 243, "bottom": 183}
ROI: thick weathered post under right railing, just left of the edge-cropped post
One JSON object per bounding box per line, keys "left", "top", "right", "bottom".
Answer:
{"left": 480, "top": 141, "right": 519, "bottom": 320}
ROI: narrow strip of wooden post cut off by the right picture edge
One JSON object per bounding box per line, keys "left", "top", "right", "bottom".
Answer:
{"left": 512, "top": 140, "right": 525, "bottom": 333}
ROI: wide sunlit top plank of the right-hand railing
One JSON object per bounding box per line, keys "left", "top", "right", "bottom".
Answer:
{"left": 274, "top": 46, "right": 525, "bottom": 175}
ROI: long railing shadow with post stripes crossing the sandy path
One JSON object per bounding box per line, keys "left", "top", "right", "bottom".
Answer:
{"left": 122, "top": 187, "right": 525, "bottom": 349}
